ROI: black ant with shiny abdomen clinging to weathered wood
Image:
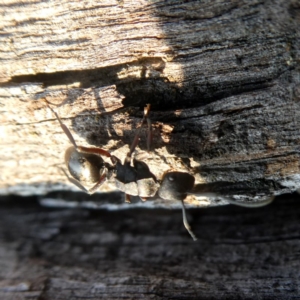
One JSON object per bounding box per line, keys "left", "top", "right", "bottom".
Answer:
{"left": 48, "top": 104, "right": 197, "bottom": 241}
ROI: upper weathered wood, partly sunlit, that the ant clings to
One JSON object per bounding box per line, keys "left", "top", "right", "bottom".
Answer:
{"left": 0, "top": 0, "right": 300, "bottom": 205}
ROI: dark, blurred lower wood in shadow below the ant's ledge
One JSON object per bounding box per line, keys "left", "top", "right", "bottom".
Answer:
{"left": 0, "top": 195, "right": 300, "bottom": 300}
